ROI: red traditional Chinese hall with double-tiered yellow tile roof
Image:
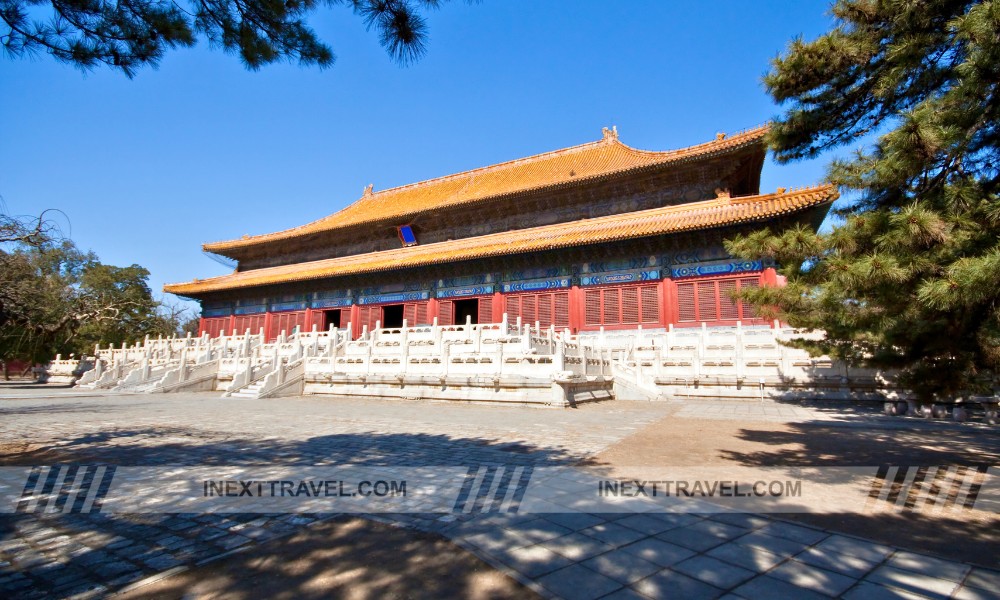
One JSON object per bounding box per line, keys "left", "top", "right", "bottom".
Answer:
{"left": 164, "top": 127, "right": 837, "bottom": 339}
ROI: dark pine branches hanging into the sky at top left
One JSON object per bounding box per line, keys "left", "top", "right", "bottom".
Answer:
{"left": 0, "top": 0, "right": 452, "bottom": 77}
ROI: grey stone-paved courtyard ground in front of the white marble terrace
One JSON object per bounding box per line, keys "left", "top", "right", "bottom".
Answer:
{"left": 0, "top": 388, "right": 1000, "bottom": 598}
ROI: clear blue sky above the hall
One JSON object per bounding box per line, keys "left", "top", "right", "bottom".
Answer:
{"left": 0, "top": 0, "right": 844, "bottom": 310}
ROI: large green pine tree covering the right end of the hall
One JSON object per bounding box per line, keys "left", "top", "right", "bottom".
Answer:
{"left": 727, "top": 0, "right": 1000, "bottom": 401}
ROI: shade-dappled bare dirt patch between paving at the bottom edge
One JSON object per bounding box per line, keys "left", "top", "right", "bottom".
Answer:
{"left": 117, "top": 517, "right": 534, "bottom": 599}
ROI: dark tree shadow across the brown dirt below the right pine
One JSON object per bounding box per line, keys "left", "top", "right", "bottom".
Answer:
{"left": 720, "top": 421, "right": 1000, "bottom": 569}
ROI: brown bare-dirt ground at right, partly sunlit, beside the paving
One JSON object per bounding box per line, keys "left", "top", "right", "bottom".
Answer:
{"left": 594, "top": 416, "right": 1000, "bottom": 569}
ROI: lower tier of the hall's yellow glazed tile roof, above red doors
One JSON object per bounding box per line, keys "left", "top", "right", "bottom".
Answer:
{"left": 170, "top": 185, "right": 839, "bottom": 296}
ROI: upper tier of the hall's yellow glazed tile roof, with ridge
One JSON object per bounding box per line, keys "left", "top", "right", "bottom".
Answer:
{"left": 202, "top": 126, "right": 767, "bottom": 253}
